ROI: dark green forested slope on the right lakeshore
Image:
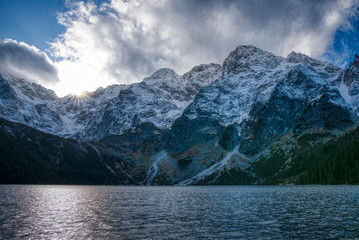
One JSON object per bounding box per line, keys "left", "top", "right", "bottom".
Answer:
{"left": 251, "top": 128, "right": 359, "bottom": 184}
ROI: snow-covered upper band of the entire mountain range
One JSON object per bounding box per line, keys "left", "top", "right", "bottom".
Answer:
{"left": 0, "top": 46, "right": 359, "bottom": 144}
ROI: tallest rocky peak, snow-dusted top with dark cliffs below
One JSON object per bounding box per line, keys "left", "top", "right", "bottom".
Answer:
{"left": 169, "top": 46, "right": 355, "bottom": 154}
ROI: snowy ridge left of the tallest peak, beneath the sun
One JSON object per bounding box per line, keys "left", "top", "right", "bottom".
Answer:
{"left": 0, "top": 64, "right": 221, "bottom": 141}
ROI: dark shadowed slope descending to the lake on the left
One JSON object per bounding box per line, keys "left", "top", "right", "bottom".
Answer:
{"left": 0, "top": 119, "right": 136, "bottom": 184}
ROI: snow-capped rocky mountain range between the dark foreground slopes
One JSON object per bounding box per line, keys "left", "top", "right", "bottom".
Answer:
{"left": 0, "top": 46, "right": 359, "bottom": 185}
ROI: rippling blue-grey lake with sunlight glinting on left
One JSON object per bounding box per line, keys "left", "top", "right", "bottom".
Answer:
{"left": 0, "top": 185, "right": 359, "bottom": 239}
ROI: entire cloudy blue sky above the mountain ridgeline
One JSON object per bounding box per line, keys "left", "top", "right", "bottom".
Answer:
{"left": 0, "top": 0, "right": 359, "bottom": 96}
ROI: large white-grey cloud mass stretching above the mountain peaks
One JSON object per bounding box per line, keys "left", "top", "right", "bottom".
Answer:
{"left": 51, "top": 0, "right": 357, "bottom": 95}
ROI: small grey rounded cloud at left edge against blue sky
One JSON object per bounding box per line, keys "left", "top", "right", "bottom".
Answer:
{"left": 0, "top": 39, "right": 59, "bottom": 86}
